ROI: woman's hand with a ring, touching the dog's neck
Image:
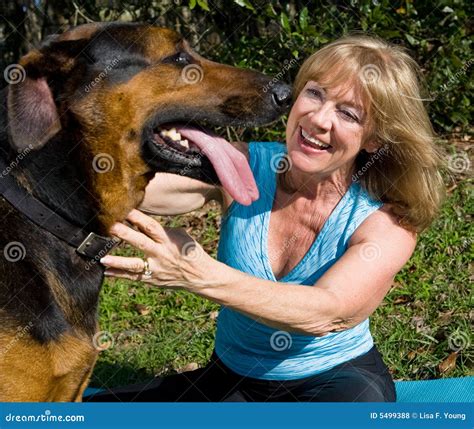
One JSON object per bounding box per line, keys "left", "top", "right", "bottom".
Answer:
{"left": 100, "top": 210, "right": 217, "bottom": 291}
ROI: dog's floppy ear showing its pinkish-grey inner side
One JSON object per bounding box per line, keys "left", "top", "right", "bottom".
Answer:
{"left": 8, "top": 62, "right": 61, "bottom": 152}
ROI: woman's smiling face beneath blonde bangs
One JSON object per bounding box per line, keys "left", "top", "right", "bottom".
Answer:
{"left": 286, "top": 81, "right": 377, "bottom": 177}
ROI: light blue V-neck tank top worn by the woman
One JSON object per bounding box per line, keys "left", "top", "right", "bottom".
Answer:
{"left": 215, "top": 142, "right": 382, "bottom": 380}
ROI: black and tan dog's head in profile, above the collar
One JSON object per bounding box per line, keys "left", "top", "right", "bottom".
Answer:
{"left": 8, "top": 23, "right": 290, "bottom": 229}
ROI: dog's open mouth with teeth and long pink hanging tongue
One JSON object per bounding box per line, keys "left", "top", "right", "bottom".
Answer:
{"left": 144, "top": 123, "right": 259, "bottom": 205}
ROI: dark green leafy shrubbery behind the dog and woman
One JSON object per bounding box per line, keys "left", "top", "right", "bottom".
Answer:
{"left": 0, "top": 0, "right": 474, "bottom": 132}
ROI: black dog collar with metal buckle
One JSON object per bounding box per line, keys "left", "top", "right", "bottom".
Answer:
{"left": 0, "top": 158, "right": 119, "bottom": 261}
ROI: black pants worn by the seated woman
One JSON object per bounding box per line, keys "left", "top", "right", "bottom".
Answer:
{"left": 84, "top": 347, "right": 396, "bottom": 402}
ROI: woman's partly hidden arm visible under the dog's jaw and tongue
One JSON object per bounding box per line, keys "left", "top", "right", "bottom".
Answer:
{"left": 138, "top": 142, "right": 248, "bottom": 215}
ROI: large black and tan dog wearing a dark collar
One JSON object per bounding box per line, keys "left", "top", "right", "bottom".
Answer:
{"left": 0, "top": 23, "right": 291, "bottom": 401}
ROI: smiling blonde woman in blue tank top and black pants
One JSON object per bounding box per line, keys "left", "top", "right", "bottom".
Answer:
{"left": 91, "top": 36, "right": 442, "bottom": 401}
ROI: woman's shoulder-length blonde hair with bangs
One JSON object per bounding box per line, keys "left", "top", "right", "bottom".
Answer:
{"left": 294, "top": 35, "right": 444, "bottom": 232}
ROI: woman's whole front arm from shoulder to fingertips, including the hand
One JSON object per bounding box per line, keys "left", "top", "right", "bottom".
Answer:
{"left": 101, "top": 210, "right": 416, "bottom": 336}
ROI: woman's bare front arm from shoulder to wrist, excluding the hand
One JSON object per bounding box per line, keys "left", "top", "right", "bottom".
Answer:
{"left": 194, "top": 207, "right": 416, "bottom": 336}
